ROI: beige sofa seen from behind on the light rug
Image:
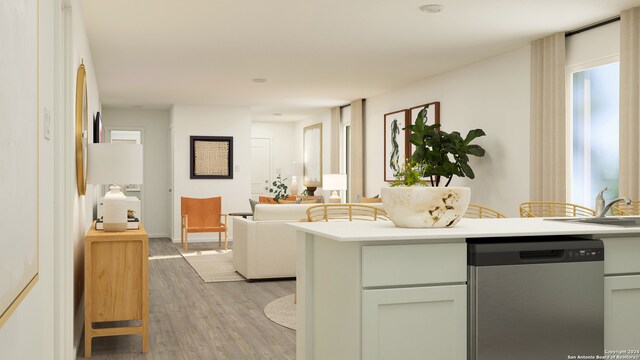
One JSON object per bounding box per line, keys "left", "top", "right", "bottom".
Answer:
{"left": 233, "top": 204, "right": 316, "bottom": 279}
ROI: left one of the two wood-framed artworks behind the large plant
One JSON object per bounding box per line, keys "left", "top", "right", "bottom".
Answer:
{"left": 384, "top": 110, "right": 411, "bottom": 181}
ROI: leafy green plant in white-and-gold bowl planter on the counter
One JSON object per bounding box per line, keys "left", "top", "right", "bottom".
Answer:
{"left": 382, "top": 107, "right": 485, "bottom": 227}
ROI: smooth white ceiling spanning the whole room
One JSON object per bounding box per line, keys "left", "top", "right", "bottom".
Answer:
{"left": 82, "top": 0, "right": 640, "bottom": 121}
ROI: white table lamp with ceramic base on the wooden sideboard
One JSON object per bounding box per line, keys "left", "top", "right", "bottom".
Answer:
{"left": 87, "top": 143, "right": 142, "bottom": 231}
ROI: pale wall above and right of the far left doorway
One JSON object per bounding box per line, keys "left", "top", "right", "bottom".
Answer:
{"left": 102, "top": 106, "right": 171, "bottom": 237}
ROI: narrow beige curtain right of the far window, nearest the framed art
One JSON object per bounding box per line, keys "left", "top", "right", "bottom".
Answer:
{"left": 349, "top": 99, "right": 364, "bottom": 202}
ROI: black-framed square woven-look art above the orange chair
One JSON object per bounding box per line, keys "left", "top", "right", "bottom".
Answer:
{"left": 189, "top": 136, "right": 233, "bottom": 179}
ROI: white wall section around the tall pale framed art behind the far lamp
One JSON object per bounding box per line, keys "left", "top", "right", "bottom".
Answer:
{"left": 293, "top": 110, "right": 331, "bottom": 197}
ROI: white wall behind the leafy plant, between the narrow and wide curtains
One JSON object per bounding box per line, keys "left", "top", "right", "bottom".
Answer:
{"left": 365, "top": 46, "right": 531, "bottom": 216}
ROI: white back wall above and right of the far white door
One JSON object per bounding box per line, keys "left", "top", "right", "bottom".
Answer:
{"left": 252, "top": 121, "right": 301, "bottom": 193}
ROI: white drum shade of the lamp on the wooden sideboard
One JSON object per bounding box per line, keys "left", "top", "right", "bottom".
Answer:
{"left": 87, "top": 143, "right": 142, "bottom": 184}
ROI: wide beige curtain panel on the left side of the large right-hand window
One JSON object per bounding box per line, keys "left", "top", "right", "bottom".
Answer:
{"left": 530, "top": 33, "right": 567, "bottom": 202}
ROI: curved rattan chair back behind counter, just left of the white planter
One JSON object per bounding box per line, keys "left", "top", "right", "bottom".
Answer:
{"left": 307, "top": 204, "right": 389, "bottom": 222}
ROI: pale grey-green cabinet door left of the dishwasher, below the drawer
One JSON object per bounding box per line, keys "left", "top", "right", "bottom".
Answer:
{"left": 362, "top": 285, "right": 467, "bottom": 360}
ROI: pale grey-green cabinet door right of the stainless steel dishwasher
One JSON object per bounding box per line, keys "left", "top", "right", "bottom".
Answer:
{"left": 604, "top": 275, "right": 640, "bottom": 350}
